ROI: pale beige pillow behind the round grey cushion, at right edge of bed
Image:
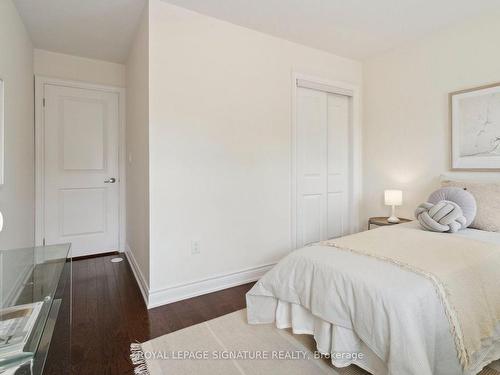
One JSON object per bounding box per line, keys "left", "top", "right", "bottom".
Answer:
{"left": 441, "top": 180, "right": 500, "bottom": 232}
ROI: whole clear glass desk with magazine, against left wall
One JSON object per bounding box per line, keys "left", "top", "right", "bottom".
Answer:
{"left": 0, "top": 244, "right": 72, "bottom": 375}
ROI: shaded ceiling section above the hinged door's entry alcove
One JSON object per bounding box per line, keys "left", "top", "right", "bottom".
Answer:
{"left": 14, "top": 0, "right": 146, "bottom": 63}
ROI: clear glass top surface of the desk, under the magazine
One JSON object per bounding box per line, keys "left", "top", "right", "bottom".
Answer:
{"left": 0, "top": 244, "right": 71, "bottom": 373}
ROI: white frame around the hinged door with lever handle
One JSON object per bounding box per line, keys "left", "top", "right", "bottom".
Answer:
{"left": 35, "top": 75, "right": 126, "bottom": 252}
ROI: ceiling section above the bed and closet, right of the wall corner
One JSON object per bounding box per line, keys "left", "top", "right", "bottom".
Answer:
{"left": 164, "top": 0, "right": 500, "bottom": 59}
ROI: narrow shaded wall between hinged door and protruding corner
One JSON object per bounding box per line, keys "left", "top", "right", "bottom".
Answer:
{"left": 126, "top": 7, "right": 149, "bottom": 287}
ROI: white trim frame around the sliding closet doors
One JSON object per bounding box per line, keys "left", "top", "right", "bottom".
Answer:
{"left": 290, "top": 71, "right": 362, "bottom": 250}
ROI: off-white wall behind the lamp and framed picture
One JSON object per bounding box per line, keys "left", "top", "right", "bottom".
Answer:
{"left": 362, "top": 14, "right": 500, "bottom": 223}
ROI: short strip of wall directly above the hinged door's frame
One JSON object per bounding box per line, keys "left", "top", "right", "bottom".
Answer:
{"left": 33, "top": 49, "right": 126, "bottom": 87}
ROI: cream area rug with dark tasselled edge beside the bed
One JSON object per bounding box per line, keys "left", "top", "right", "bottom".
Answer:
{"left": 130, "top": 310, "right": 500, "bottom": 375}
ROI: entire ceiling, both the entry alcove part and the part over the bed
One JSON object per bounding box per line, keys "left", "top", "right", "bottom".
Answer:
{"left": 14, "top": 0, "right": 500, "bottom": 63}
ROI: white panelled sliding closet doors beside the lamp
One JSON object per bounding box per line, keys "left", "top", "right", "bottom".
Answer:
{"left": 296, "top": 88, "right": 350, "bottom": 247}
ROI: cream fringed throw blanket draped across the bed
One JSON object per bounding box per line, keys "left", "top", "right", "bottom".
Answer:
{"left": 322, "top": 227, "right": 500, "bottom": 368}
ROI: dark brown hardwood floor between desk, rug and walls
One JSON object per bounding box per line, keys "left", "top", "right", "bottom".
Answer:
{"left": 46, "top": 255, "right": 253, "bottom": 375}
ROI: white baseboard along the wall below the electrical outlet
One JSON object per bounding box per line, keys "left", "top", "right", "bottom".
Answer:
{"left": 148, "top": 263, "right": 274, "bottom": 309}
